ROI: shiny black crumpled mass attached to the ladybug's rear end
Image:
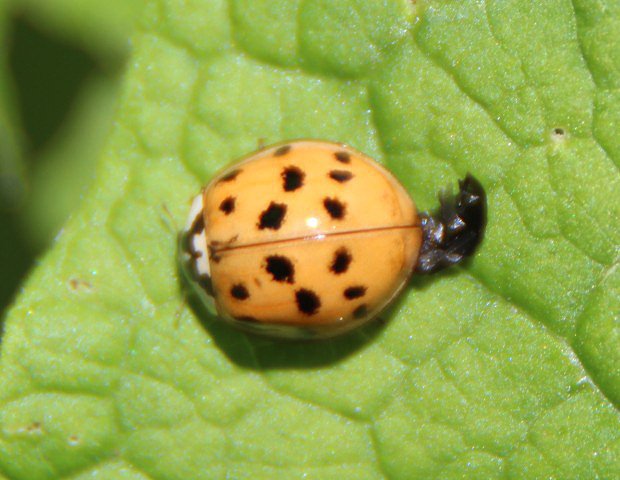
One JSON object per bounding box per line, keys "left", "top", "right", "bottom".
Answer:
{"left": 416, "top": 173, "right": 487, "bottom": 273}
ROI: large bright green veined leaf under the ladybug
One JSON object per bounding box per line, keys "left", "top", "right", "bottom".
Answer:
{"left": 0, "top": 0, "right": 620, "bottom": 479}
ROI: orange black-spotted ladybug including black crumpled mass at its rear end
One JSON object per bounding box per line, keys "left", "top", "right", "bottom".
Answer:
{"left": 180, "top": 140, "right": 486, "bottom": 338}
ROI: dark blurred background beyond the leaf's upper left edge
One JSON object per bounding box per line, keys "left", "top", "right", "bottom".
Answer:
{"left": 0, "top": 9, "right": 128, "bottom": 324}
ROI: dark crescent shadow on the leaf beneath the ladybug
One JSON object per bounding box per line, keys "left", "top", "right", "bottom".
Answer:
{"left": 188, "top": 269, "right": 458, "bottom": 371}
